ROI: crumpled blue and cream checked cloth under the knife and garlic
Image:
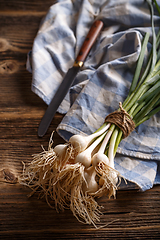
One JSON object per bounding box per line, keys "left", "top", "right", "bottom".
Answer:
{"left": 27, "top": 0, "right": 160, "bottom": 190}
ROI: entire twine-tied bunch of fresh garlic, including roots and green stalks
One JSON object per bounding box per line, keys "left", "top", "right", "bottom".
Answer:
{"left": 19, "top": 0, "right": 160, "bottom": 226}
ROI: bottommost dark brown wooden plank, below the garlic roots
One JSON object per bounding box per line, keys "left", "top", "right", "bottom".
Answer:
{"left": 0, "top": 184, "right": 160, "bottom": 239}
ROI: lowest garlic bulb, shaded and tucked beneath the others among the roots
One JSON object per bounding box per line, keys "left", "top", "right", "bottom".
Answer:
{"left": 83, "top": 166, "right": 99, "bottom": 194}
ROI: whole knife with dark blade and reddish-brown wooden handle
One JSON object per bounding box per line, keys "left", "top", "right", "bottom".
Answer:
{"left": 38, "top": 20, "right": 103, "bottom": 137}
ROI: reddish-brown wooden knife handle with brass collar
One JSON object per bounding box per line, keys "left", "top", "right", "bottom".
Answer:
{"left": 75, "top": 20, "right": 103, "bottom": 67}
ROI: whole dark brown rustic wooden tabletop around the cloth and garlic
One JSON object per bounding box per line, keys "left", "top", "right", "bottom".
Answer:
{"left": 0, "top": 0, "right": 160, "bottom": 240}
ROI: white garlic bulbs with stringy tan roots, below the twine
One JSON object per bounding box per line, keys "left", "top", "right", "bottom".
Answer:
{"left": 19, "top": 123, "right": 119, "bottom": 225}
